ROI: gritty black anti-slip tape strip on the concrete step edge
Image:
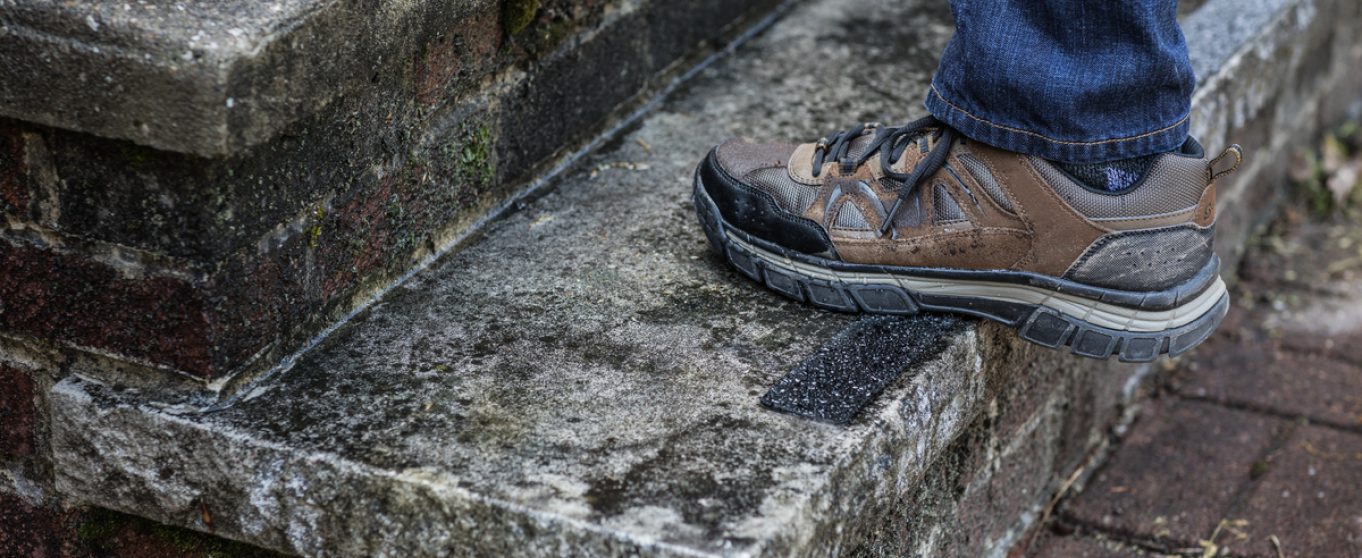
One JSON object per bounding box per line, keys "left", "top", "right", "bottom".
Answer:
{"left": 761, "top": 314, "right": 964, "bottom": 425}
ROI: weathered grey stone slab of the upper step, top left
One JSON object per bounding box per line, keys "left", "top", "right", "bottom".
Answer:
{"left": 0, "top": 0, "right": 772, "bottom": 157}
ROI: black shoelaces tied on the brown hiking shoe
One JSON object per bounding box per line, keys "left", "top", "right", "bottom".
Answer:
{"left": 813, "top": 116, "right": 956, "bottom": 237}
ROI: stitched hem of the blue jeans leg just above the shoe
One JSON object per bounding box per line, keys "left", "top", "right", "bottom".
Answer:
{"left": 926, "top": 83, "right": 1188, "bottom": 163}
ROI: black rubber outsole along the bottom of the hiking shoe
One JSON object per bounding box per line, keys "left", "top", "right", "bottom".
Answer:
{"left": 695, "top": 176, "right": 1230, "bottom": 362}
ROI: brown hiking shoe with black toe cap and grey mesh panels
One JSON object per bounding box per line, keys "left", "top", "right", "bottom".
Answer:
{"left": 695, "top": 117, "right": 1242, "bottom": 361}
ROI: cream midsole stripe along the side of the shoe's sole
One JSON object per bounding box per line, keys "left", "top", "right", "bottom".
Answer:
{"left": 729, "top": 234, "right": 1226, "bottom": 332}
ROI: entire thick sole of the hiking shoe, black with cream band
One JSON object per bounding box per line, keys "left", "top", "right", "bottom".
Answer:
{"left": 695, "top": 176, "right": 1230, "bottom": 362}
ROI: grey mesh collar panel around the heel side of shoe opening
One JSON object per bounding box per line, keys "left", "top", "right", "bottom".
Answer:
{"left": 1028, "top": 155, "right": 1207, "bottom": 219}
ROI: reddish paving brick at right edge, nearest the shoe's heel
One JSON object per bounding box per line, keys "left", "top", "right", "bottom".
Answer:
{"left": 1178, "top": 343, "right": 1362, "bottom": 426}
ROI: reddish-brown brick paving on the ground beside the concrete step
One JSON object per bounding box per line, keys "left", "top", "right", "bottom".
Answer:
{"left": 1027, "top": 210, "right": 1362, "bottom": 558}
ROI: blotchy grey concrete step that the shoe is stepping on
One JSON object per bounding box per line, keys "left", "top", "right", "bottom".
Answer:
{"left": 37, "top": 0, "right": 1362, "bottom": 555}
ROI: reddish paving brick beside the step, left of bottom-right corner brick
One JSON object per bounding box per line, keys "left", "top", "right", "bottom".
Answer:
{"left": 1064, "top": 399, "right": 1283, "bottom": 548}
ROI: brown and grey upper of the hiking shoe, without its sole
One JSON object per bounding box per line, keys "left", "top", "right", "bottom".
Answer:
{"left": 700, "top": 121, "right": 1215, "bottom": 290}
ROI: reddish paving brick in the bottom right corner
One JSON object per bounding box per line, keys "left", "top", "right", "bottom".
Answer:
{"left": 1235, "top": 426, "right": 1362, "bottom": 558}
